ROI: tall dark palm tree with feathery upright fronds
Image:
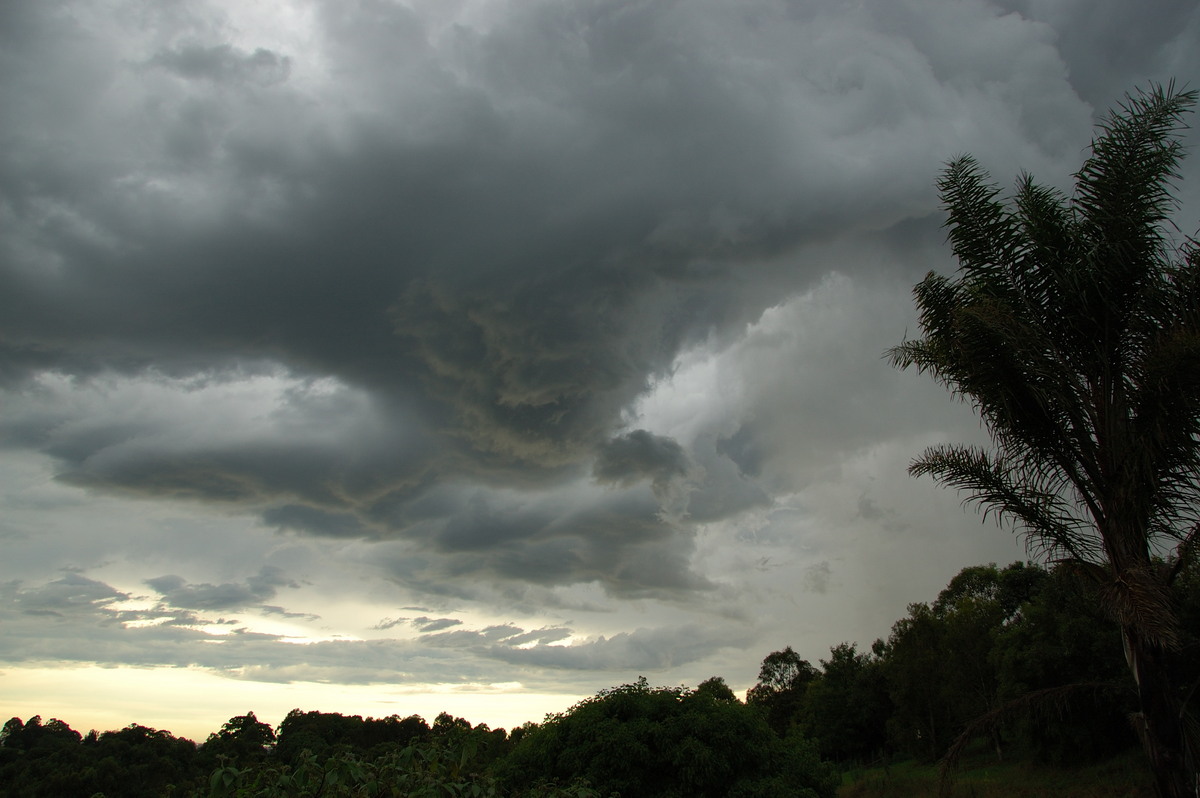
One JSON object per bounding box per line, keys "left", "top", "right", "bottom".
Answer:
{"left": 888, "top": 83, "right": 1200, "bottom": 798}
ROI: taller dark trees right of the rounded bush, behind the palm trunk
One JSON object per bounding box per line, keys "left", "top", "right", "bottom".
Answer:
{"left": 746, "top": 554, "right": 1200, "bottom": 766}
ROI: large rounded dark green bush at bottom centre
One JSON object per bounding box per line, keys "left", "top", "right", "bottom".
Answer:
{"left": 497, "top": 678, "right": 835, "bottom": 798}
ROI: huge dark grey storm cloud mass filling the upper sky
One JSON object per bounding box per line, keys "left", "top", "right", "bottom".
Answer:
{"left": 0, "top": 0, "right": 1196, "bottom": 609}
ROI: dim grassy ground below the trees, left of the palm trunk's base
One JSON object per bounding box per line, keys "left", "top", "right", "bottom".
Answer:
{"left": 838, "top": 751, "right": 1154, "bottom": 798}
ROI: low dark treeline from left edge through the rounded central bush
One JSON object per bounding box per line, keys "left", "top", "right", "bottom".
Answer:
{"left": 0, "top": 678, "right": 838, "bottom": 798}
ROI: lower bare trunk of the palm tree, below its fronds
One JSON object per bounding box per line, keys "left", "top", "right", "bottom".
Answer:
{"left": 1122, "top": 626, "right": 1200, "bottom": 798}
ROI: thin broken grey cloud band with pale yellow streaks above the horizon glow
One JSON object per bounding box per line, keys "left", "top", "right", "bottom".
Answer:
{"left": 0, "top": 574, "right": 740, "bottom": 690}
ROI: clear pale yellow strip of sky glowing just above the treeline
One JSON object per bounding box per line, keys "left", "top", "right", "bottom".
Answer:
{"left": 0, "top": 665, "right": 586, "bottom": 743}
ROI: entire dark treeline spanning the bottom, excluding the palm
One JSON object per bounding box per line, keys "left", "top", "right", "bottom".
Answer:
{"left": 0, "top": 563, "right": 1200, "bottom": 798}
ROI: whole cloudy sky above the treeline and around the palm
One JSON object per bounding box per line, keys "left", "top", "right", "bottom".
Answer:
{"left": 0, "top": 0, "right": 1200, "bottom": 740}
